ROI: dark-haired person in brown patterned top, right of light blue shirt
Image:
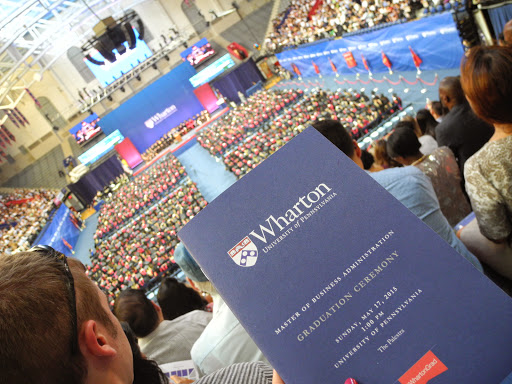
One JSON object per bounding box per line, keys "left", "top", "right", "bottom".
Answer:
{"left": 387, "top": 127, "right": 471, "bottom": 227}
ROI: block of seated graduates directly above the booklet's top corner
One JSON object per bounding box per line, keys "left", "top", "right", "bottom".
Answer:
{"left": 220, "top": 89, "right": 401, "bottom": 178}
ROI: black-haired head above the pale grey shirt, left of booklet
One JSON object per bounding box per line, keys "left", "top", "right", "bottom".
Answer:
{"left": 157, "top": 277, "right": 208, "bottom": 320}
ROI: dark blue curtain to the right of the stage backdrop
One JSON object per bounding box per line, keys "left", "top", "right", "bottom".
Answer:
{"left": 211, "top": 59, "right": 263, "bottom": 103}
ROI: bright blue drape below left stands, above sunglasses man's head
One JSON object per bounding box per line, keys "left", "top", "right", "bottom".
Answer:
{"left": 33, "top": 204, "right": 80, "bottom": 256}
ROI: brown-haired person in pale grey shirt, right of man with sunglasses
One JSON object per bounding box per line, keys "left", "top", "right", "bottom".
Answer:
{"left": 114, "top": 289, "right": 212, "bottom": 364}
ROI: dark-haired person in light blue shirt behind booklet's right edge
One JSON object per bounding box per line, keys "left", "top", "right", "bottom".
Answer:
{"left": 313, "top": 120, "right": 482, "bottom": 271}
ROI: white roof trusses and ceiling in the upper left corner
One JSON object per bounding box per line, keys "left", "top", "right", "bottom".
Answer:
{"left": 0, "top": 0, "right": 148, "bottom": 110}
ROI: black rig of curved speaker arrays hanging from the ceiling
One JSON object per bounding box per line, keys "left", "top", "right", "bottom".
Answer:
{"left": 82, "top": 10, "right": 144, "bottom": 65}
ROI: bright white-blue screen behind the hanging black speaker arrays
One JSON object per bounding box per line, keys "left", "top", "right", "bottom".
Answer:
{"left": 84, "top": 28, "right": 153, "bottom": 87}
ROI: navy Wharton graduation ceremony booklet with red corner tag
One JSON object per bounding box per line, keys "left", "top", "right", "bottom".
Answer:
{"left": 179, "top": 128, "right": 512, "bottom": 384}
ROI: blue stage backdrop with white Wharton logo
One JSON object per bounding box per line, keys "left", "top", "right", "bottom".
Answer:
{"left": 100, "top": 63, "right": 204, "bottom": 153}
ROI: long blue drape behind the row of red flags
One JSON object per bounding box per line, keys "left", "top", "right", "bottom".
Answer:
{"left": 277, "top": 13, "right": 464, "bottom": 77}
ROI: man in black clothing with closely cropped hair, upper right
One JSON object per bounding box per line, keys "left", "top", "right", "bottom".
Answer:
{"left": 436, "top": 77, "right": 494, "bottom": 170}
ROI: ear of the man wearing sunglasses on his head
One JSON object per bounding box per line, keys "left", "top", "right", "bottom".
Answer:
{"left": 79, "top": 320, "right": 117, "bottom": 358}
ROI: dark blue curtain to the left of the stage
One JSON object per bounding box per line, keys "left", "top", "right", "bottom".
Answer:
{"left": 68, "top": 156, "right": 124, "bottom": 205}
